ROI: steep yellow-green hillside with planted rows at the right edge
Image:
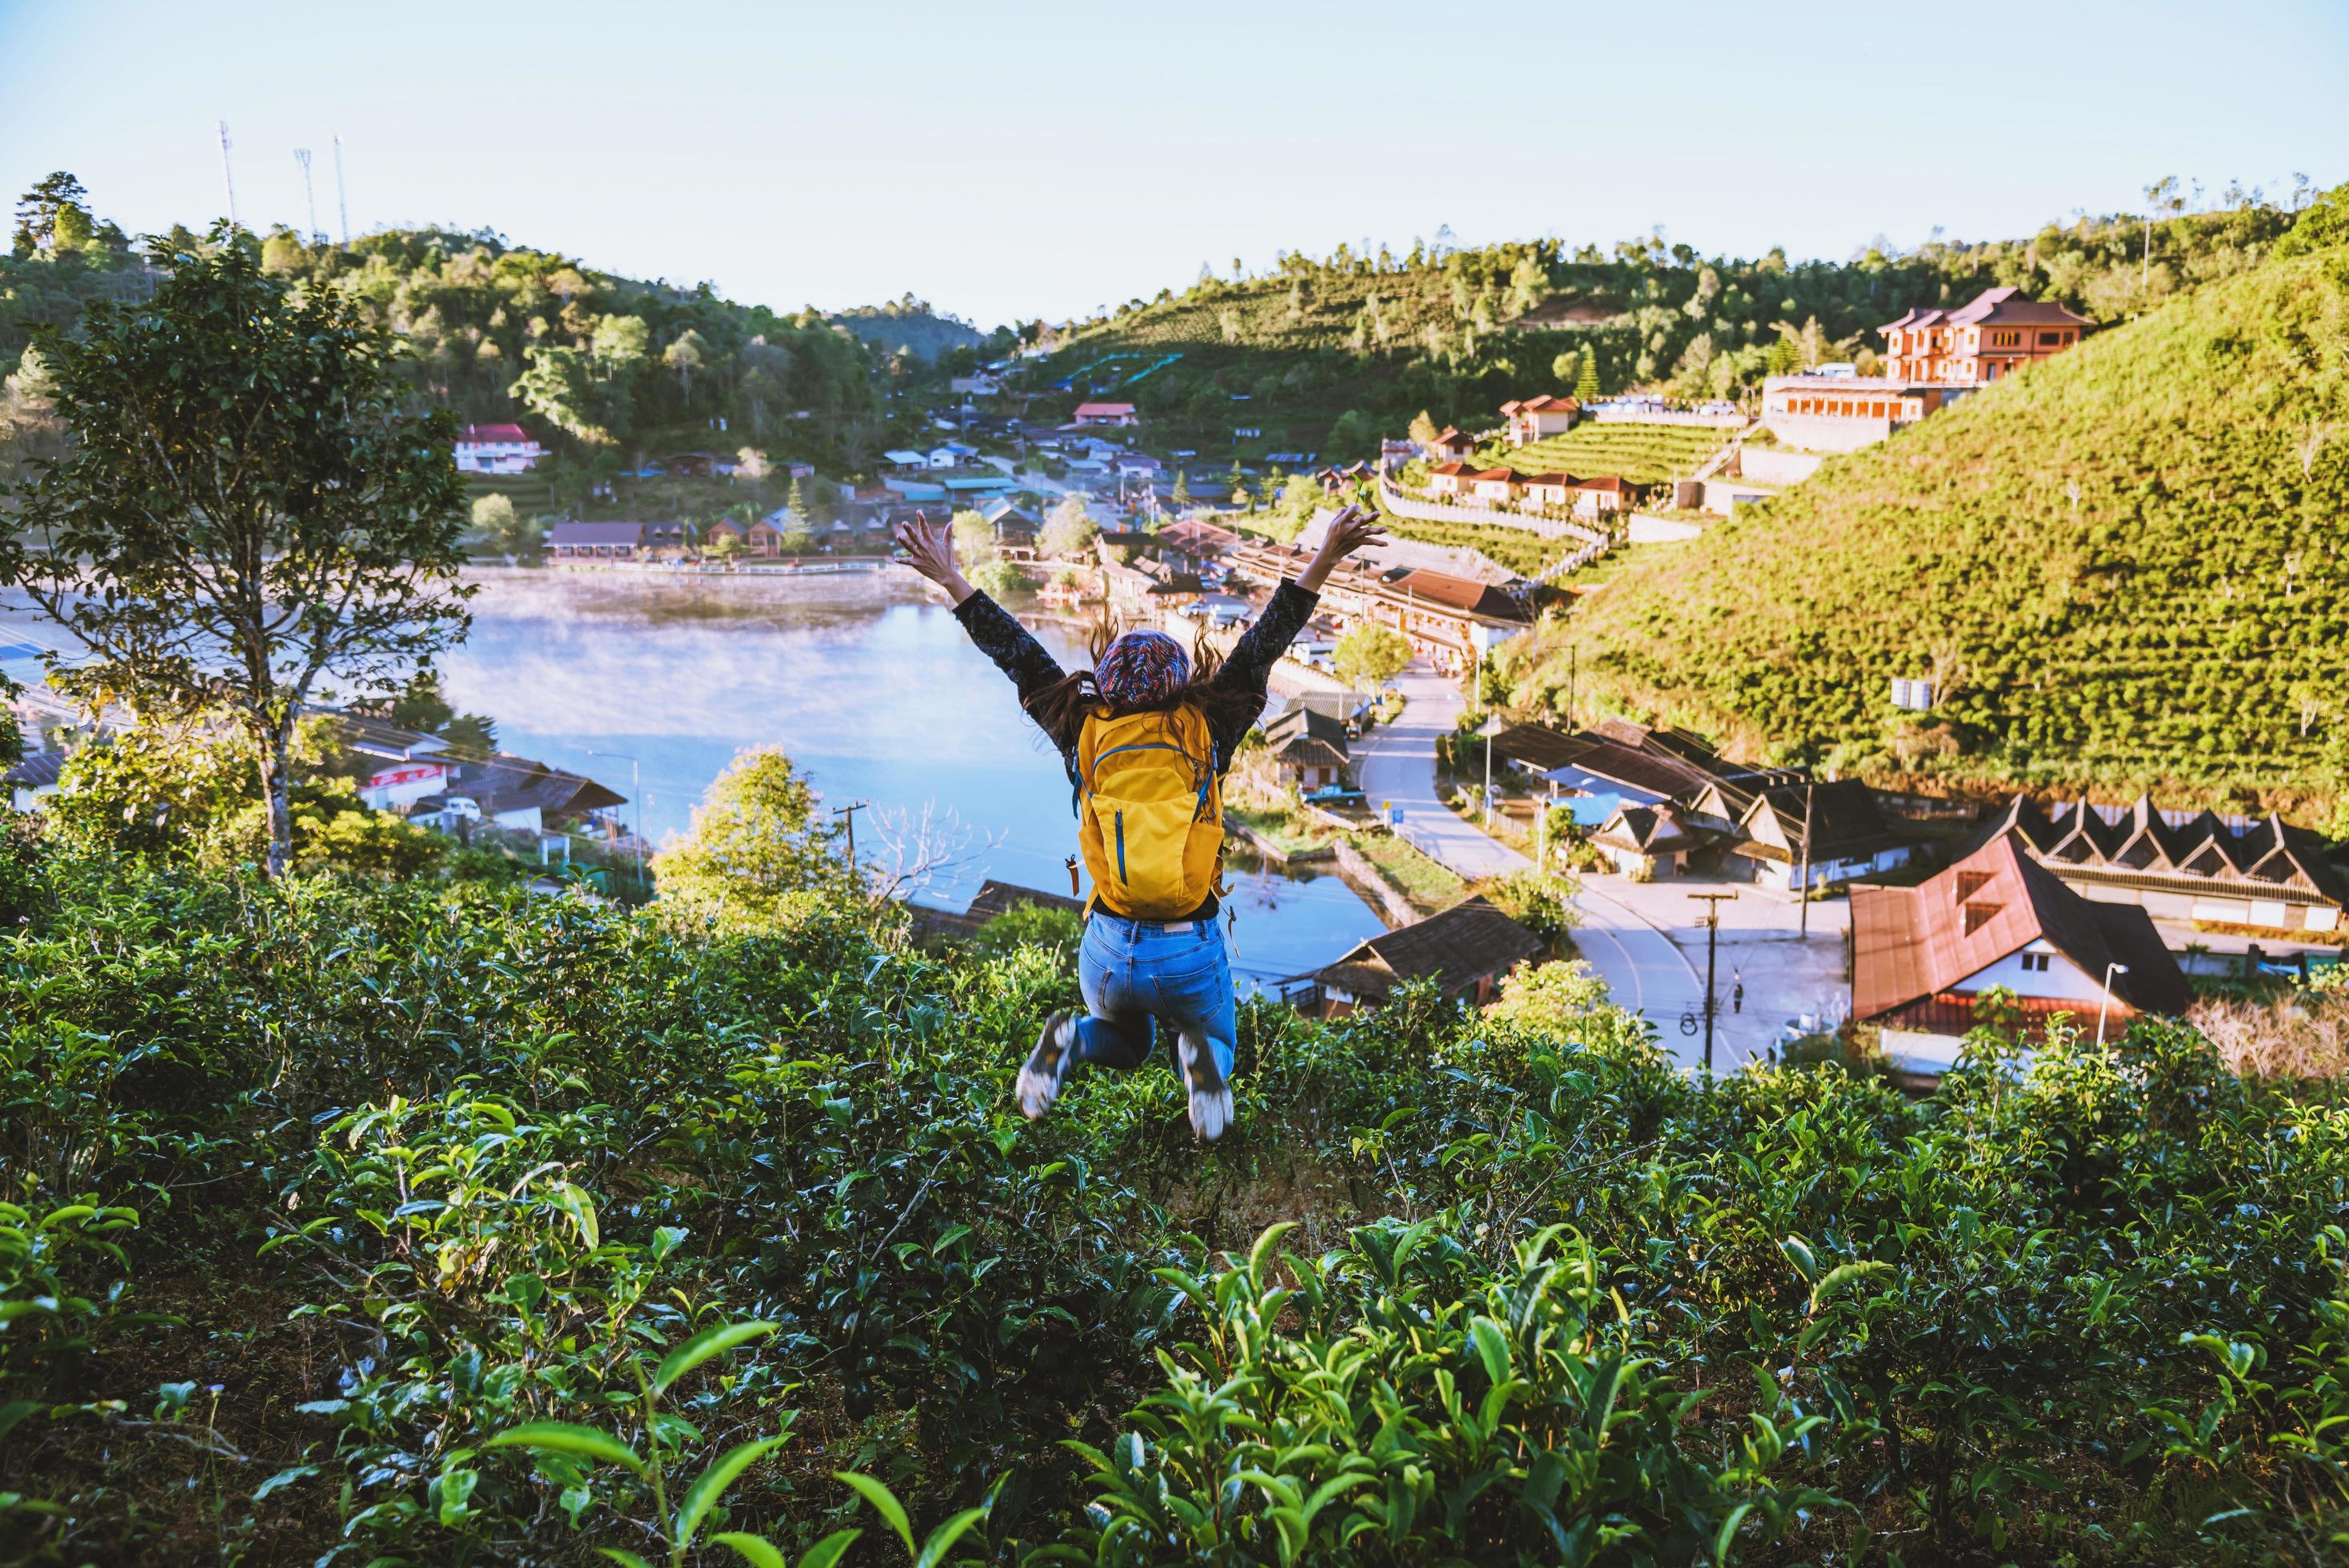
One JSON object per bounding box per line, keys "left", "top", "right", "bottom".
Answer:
{"left": 1536, "top": 220, "right": 2349, "bottom": 821}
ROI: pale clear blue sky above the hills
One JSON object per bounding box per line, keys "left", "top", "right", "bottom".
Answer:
{"left": 0, "top": 0, "right": 2349, "bottom": 326}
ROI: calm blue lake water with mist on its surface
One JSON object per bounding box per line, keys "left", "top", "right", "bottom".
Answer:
{"left": 442, "top": 570, "right": 1383, "bottom": 983}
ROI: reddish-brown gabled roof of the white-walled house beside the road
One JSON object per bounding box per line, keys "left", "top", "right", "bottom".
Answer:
{"left": 1851, "top": 834, "right": 2187, "bottom": 1018}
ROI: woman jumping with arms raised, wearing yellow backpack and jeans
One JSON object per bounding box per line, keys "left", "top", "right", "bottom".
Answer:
{"left": 898, "top": 507, "right": 1383, "bottom": 1138}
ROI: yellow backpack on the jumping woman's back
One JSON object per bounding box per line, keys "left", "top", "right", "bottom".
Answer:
{"left": 1076, "top": 704, "right": 1224, "bottom": 920}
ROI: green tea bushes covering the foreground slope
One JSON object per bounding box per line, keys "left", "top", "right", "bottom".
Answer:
{"left": 0, "top": 842, "right": 2349, "bottom": 1568}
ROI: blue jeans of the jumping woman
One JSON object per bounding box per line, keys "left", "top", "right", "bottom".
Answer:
{"left": 1069, "top": 910, "right": 1238, "bottom": 1080}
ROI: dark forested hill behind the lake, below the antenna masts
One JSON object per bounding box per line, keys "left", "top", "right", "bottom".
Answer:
{"left": 0, "top": 209, "right": 888, "bottom": 472}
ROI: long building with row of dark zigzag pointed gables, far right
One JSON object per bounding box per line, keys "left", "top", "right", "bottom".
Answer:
{"left": 1990, "top": 796, "right": 2349, "bottom": 932}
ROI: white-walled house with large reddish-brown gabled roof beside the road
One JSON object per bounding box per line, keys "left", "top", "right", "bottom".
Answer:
{"left": 1851, "top": 834, "right": 2187, "bottom": 1075}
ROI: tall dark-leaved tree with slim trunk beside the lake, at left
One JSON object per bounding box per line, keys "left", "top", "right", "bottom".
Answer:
{"left": 12, "top": 223, "right": 472, "bottom": 875}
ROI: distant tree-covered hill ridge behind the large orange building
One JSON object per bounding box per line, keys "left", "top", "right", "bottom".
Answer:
{"left": 1036, "top": 190, "right": 2299, "bottom": 455}
